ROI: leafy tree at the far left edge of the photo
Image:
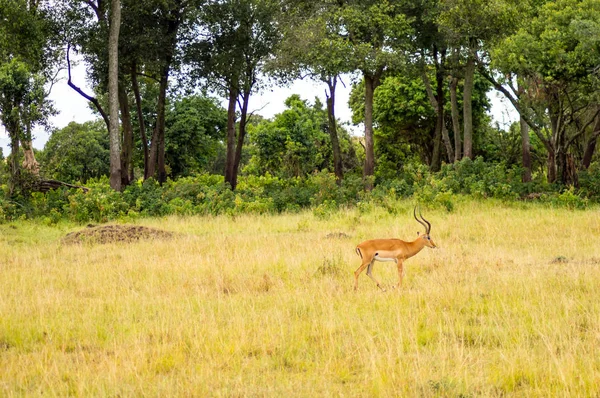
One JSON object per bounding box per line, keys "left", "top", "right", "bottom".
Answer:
{"left": 0, "top": 0, "right": 56, "bottom": 192}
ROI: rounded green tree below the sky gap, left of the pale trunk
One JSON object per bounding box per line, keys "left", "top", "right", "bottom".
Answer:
{"left": 40, "top": 120, "right": 110, "bottom": 184}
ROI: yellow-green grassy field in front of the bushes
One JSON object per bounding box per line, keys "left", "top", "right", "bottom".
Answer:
{"left": 0, "top": 202, "right": 600, "bottom": 397}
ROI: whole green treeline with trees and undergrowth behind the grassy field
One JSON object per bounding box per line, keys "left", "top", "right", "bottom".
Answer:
{"left": 0, "top": 0, "right": 600, "bottom": 221}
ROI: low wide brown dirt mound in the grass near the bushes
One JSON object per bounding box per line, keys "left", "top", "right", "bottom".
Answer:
{"left": 63, "top": 224, "right": 174, "bottom": 244}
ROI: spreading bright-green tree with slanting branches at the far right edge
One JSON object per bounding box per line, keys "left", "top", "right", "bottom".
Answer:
{"left": 490, "top": 0, "right": 600, "bottom": 183}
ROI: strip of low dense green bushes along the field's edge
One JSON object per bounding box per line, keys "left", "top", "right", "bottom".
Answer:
{"left": 0, "top": 158, "right": 600, "bottom": 223}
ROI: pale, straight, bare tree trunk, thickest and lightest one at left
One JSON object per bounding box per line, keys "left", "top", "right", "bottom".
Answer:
{"left": 108, "top": 0, "right": 121, "bottom": 191}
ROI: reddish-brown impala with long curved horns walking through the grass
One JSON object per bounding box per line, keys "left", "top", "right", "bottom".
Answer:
{"left": 354, "top": 206, "right": 436, "bottom": 291}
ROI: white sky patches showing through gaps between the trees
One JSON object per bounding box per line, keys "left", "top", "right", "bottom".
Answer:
{"left": 0, "top": 64, "right": 517, "bottom": 156}
